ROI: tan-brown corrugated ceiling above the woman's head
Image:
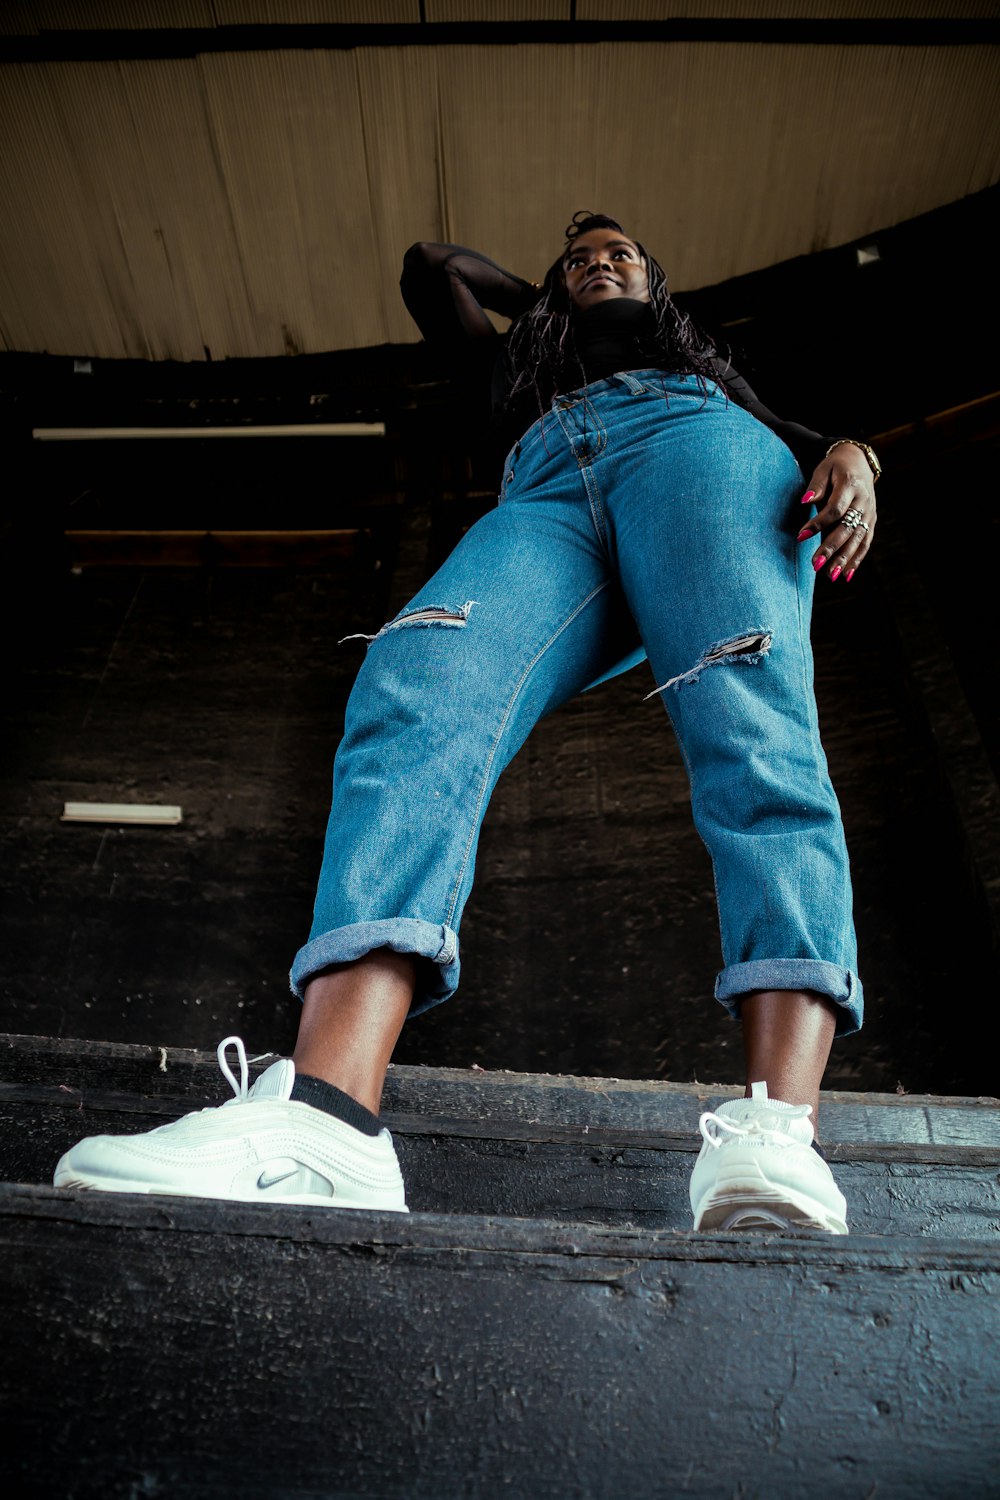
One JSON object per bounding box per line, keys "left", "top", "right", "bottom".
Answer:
{"left": 0, "top": 0, "right": 1000, "bottom": 360}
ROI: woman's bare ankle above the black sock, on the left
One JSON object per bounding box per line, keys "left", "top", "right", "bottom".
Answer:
{"left": 292, "top": 948, "right": 417, "bottom": 1115}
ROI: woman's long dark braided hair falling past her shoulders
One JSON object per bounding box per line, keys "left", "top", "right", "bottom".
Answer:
{"left": 504, "top": 209, "right": 718, "bottom": 438}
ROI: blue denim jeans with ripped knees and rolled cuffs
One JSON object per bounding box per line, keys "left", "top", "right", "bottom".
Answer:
{"left": 291, "top": 371, "right": 862, "bottom": 1035}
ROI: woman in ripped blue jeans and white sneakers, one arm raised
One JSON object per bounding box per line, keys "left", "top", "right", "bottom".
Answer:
{"left": 55, "top": 213, "right": 879, "bottom": 1233}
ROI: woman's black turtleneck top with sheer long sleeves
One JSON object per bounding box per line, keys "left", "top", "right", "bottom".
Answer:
{"left": 399, "top": 243, "right": 835, "bottom": 479}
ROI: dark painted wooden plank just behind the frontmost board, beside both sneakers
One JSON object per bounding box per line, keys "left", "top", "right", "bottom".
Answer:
{"left": 0, "top": 1085, "right": 1000, "bottom": 1239}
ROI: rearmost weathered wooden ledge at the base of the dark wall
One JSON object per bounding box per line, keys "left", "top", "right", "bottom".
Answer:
{"left": 0, "top": 1035, "right": 1000, "bottom": 1146}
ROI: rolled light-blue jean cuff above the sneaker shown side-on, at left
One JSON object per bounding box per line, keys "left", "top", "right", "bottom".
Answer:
{"left": 288, "top": 917, "right": 460, "bottom": 1016}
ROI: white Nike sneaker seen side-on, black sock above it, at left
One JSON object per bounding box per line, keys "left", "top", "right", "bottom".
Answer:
{"left": 52, "top": 1037, "right": 408, "bottom": 1214}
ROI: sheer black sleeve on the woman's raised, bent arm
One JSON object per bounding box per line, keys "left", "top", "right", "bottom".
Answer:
{"left": 399, "top": 240, "right": 538, "bottom": 350}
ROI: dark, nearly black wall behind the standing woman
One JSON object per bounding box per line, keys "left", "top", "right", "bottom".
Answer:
{"left": 0, "top": 191, "right": 1000, "bottom": 1094}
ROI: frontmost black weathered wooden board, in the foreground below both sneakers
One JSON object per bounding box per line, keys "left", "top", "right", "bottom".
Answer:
{"left": 0, "top": 1188, "right": 1000, "bottom": 1500}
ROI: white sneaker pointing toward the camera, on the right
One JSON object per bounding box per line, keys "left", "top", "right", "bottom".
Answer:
{"left": 691, "top": 1083, "right": 847, "bottom": 1235}
